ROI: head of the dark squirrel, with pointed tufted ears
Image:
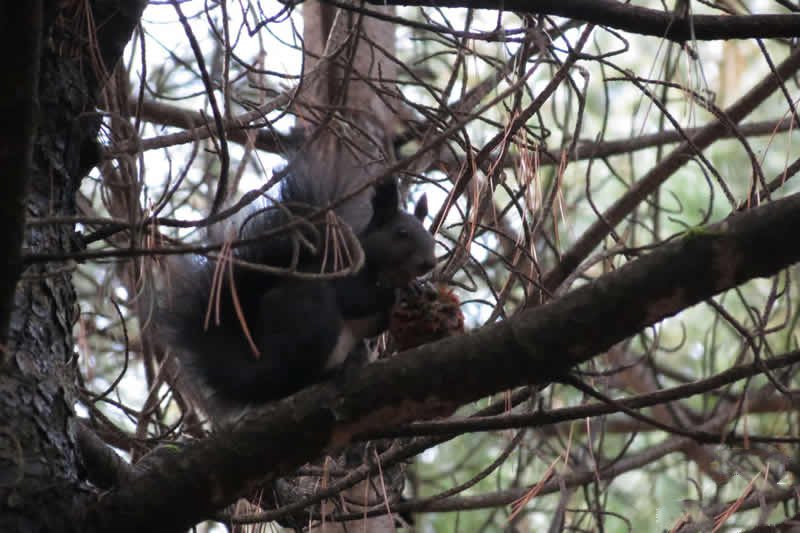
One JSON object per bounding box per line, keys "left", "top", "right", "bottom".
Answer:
{"left": 361, "top": 180, "right": 436, "bottom": 288}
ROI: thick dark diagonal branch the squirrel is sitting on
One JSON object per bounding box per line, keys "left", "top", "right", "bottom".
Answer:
{"left": 87, "top": 189, "right": 800, "bottom": 531}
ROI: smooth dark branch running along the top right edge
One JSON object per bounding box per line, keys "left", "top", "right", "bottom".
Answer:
{"left": 369, "top": 0, "right": 800, "bottom": 43}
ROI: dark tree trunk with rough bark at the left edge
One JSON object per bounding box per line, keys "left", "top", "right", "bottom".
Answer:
{"left": 0, "top": 1, "right": 143, "bottom": 532}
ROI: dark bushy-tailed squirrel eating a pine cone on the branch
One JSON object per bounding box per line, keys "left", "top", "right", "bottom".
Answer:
{"left": 155, "top": 160, "right": 435, "bottom": 419}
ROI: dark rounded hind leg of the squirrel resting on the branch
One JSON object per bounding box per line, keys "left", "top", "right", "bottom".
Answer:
{"left": 186, "top": 279, "right": 342, "bottom": 407}
